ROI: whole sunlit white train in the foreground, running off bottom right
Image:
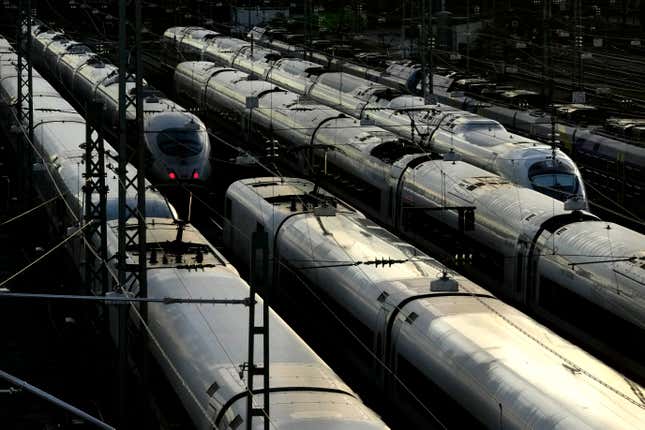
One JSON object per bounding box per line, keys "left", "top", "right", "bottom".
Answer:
{"left": 224, "top": 177, "right": 645, "bottom": 430}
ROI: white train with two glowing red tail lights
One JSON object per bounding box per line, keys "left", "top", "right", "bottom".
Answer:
{"left": 31, "top": 24, "right": 211, "bottom": 185}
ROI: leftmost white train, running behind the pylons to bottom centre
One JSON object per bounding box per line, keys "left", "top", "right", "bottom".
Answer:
{"left": 0, "top": 39, "right": 387, "bottom": 430}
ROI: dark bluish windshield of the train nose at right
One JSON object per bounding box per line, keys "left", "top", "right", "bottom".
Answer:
{"left": 529, "top": 160, "right": 579, "bottom": 200}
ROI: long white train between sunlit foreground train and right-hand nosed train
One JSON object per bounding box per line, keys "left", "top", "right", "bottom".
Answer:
{"left": 175, "top": 62, "right": 645, "bottom": 342}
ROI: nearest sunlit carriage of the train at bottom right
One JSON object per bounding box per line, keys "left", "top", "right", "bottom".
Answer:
{"left": 396, "top": 297, "right": 643, "bottom": 430}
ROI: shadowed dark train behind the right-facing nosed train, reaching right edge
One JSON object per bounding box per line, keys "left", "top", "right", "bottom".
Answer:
{"left": 249, "top": 27, "right": 645, "bottom": 219}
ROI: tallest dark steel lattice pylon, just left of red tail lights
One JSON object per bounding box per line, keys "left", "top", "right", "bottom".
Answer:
{"left": 117, "top": 0, "right": 148, "bottom": 428}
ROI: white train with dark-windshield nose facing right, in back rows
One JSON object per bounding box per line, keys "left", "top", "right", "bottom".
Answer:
{"left": 164, "top": 27, "right": 586, "bottom": 204}
